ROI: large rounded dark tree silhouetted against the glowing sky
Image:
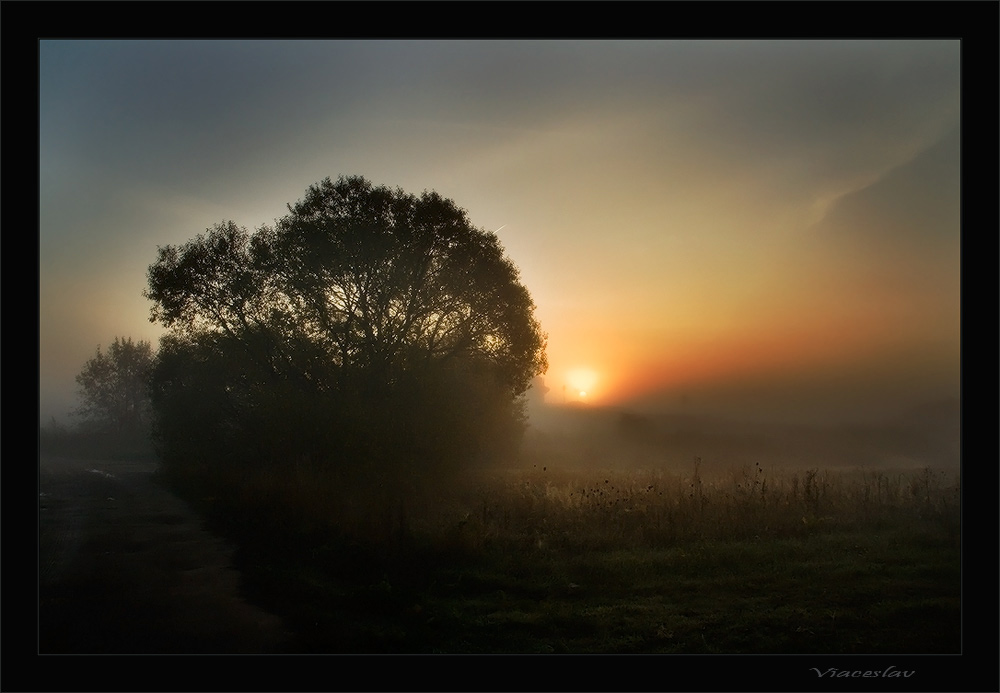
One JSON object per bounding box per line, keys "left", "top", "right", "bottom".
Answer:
{"left": 146, "top": 177, "right": 546, "bottom": 474}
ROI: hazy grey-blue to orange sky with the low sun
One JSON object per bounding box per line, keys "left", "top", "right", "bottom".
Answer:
{"left": 39, "top": 39, "right": 961, "bottom": 423}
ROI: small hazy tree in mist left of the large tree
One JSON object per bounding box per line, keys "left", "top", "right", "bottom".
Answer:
{"left": 76, "top": 337, "right": 153, "bottom": 433}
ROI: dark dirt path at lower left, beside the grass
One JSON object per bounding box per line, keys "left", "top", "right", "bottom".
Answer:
{"left": 39, "top": 457, "right": 294, "bottom": 654}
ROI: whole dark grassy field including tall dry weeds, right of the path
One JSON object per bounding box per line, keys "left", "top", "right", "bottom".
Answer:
{"left": 166, "top": 460, "right": 961, "bottom": 654}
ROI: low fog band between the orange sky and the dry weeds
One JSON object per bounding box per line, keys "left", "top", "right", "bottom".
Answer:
{"left": 521, "top": 390, "right": 961, "bottom": 482}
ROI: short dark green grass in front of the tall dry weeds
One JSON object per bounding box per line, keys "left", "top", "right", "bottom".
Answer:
{"left": 234, "top": 533, "right": 960, "bottom": 653}
